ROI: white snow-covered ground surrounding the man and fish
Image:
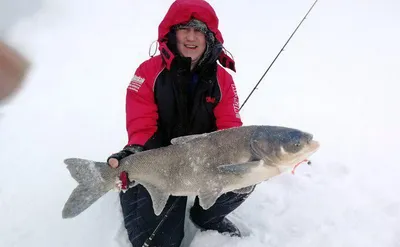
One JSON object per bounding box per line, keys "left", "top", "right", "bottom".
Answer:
{"left": 0, "top": 0, "right": 400, "bottom": 247}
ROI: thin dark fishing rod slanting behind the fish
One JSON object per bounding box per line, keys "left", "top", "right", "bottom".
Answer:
{"left": 142, "top": 0, "right": 318, "bottom": 247}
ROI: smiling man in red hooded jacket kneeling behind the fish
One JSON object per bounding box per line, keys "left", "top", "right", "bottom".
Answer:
{"left": 108, "top": 0, "right": 255, "bottom": 246}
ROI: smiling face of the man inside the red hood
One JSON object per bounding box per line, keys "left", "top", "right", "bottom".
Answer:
{"left": 176, "top": 27, "right": 206, "bottom": 64}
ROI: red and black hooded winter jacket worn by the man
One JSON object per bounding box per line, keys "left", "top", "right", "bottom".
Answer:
{"left": 126, "top": 0, "right": 242, "bottom": 149}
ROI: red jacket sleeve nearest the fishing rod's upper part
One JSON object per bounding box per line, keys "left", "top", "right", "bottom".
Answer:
{"left": 214, "top": 71, "right": 243, "bottom": 130}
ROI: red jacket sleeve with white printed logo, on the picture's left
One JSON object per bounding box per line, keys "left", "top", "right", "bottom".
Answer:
{"left": 125, "top": 64, "right": 158, "bottom": 146}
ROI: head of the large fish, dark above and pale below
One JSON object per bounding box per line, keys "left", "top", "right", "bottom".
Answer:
{"left": 251, "top": 126, "right": 319, "bottom": 172}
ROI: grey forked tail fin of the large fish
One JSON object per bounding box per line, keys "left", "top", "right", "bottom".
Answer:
{"left": 62, "top": 158, "right": 112, "bottom": 219}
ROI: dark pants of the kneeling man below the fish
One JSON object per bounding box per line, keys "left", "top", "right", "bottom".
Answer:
{"left": 120, "top": 185, "right": 255, "bottom": 247}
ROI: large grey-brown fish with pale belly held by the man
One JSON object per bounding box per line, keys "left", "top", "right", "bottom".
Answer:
{"left": 62, "top": 126, "right": 319, "bottom": 218}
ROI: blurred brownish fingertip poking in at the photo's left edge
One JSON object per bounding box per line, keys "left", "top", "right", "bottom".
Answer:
{"left": 0, "top": 41, "right": 29, "bottom": 101}
